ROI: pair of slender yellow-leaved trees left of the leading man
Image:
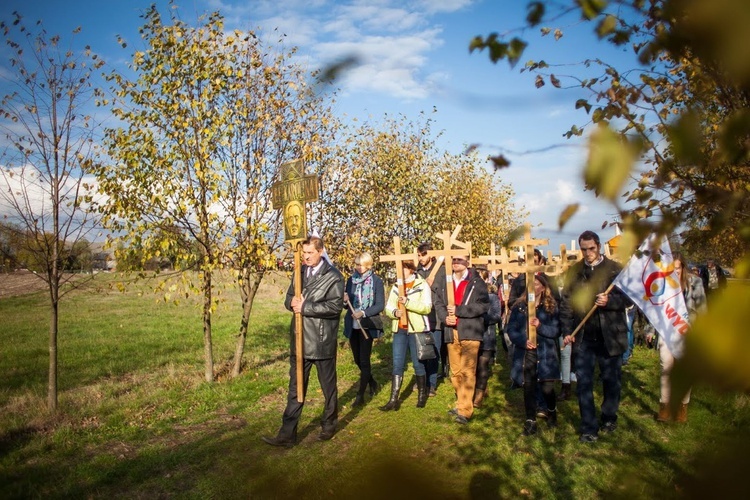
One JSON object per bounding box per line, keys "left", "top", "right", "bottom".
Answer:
{"left": 98, "top": 6, "right": 334, "bottom": 381}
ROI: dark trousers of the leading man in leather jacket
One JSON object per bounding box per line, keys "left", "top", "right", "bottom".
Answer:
{"left": 278, "top": 355, "right": 339, "bottom": 440}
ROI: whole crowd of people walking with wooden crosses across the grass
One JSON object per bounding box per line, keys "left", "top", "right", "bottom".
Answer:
{"left": 263, "top": 231, "right": 726, "bottom": 447}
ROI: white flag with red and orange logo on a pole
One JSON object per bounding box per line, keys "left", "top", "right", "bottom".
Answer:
{"left": 614, "top": 235, "right": 689, "bottom": 358}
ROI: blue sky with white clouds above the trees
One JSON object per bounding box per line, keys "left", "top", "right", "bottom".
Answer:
{"left": 0, "top": 0, "right": 648, "bottom": 251}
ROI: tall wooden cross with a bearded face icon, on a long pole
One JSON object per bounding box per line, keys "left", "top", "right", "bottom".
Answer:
{"left": 271, "top": 159, "right": 320, "bottom": 403}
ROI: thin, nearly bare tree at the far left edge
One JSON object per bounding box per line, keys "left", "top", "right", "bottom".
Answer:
{"left": 0, "top": 12, "right": 102, "bottom": 411}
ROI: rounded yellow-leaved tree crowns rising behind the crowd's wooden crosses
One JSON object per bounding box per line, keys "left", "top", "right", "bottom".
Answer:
{"left": 314, "top": 112, "right": 524, "bottom": 269}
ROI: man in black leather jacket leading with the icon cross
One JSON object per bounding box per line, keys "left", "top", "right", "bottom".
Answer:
{"left": 263, "top": 236, "right": 344, "bottom": 448}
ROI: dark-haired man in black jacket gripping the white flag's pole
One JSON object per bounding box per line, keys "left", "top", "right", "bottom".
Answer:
{"left": 560, "top": 231, "right": 631, "bottom": 442}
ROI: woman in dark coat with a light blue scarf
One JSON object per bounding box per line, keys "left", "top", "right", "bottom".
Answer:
{"left": 344, "top": 252, "right": 385, "bottom": 406}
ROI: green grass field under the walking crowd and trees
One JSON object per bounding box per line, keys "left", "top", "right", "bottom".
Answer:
{"left": 0, "top": 275, "right": 750, "bottom": 499}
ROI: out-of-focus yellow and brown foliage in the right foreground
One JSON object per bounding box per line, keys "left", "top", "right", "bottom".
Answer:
{"left": 470, "top": 0, "right": 750, "bottom": 390}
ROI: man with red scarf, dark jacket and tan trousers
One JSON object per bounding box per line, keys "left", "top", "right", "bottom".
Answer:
{"left": 434, "top": 255, "right": 490, "bottom": 424}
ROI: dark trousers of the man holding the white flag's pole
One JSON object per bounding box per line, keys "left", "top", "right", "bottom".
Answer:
{"left": 575, "top": 341, "right": 622, "bottom": 434}
